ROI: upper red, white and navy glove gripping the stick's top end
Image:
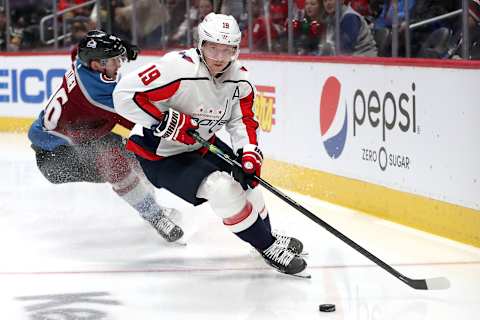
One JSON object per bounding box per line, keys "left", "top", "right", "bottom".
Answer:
{"left": 152, "top": 108, "right": 198, "bottom": 144}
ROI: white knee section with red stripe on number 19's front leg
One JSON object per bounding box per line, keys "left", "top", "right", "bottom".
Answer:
{"left": 197, "top": 171, "right": 258, "bottom": 232}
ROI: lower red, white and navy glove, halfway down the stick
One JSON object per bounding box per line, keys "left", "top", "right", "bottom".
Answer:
{"left": 232, "top": 144, "right": 263, "bottom": 190}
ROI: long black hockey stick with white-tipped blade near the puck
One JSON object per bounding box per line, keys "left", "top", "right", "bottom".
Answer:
{"left": 189, "top": 131, "right": 450, "bottom": 290}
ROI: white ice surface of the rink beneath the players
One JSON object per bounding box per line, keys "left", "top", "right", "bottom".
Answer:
{"left": 0, "top": 134, "right": 480, "bottom": 320}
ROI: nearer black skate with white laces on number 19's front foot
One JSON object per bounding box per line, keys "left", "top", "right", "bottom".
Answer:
{"left": 261, "top": 239, "right": 310, "bottom": 278}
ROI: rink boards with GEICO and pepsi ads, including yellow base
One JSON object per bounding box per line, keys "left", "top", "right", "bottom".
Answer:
{"left": 0, "top": 55, "right": 480, "bottom": 246}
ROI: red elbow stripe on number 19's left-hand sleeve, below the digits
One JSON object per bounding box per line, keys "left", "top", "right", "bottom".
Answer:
{"left": 133, "top": 80, "right": 180, "bottom": 121}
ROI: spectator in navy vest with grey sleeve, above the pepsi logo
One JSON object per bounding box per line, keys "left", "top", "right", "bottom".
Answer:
{"left": 323, "top": 0, "right": 378, "bottom": 57}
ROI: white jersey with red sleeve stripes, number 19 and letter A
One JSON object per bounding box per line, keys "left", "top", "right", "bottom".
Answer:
{"left": 113, "top": 49, "right": 258, "bottom": 160}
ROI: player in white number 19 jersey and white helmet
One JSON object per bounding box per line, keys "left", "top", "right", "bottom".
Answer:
{"left": 113, "top": 13, "right": 306, "bottom": 274}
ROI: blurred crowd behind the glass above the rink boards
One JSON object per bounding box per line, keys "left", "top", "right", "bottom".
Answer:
{"left": 0, "top": 0, "right": 480, "bottom": 59}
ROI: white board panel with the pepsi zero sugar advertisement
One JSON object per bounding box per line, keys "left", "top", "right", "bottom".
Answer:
{"left": 246, "top": 61, "right": 480, "bottom": 209}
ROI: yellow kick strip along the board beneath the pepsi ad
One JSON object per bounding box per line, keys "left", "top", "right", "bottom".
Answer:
{"left": 262, "top": 160, "right": 480, "bottom": 247}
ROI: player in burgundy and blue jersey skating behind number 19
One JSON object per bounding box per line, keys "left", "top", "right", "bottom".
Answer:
{"left": 28, "top": 30, "right": 183, "bottom": 242}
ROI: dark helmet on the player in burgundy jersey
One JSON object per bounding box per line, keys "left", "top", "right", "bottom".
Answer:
{"left": 78, "top": 30, "right": 126, "bottom": 67}
